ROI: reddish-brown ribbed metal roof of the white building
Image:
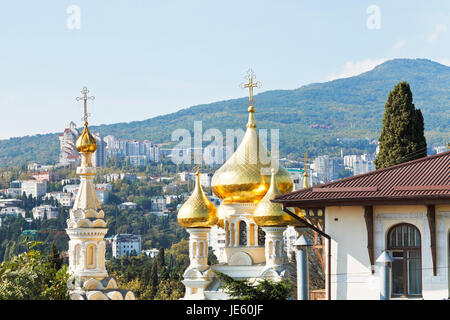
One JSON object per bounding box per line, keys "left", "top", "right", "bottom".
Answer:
{"left": 273, "top": 151, "right": 450, "bottom": 206}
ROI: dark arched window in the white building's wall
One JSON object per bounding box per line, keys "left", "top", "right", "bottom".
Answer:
{"left": 388, "top": 223, "right": 422, "bottom": 296}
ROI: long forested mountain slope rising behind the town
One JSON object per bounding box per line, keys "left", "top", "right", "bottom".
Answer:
{"left": 0, "top": 59, "right": 450, "bottom": 166}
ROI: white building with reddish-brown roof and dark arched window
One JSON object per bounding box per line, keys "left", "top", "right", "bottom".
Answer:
{"left": 275, "top": 152, "right": 450, "bottom": 299}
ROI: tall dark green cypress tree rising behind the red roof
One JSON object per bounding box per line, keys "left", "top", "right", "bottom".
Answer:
{"left": 375, "top": 81, "right": 427, "bottom": 169}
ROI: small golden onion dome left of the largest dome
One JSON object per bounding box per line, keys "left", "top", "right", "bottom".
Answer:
{"left": 177, "top": 171, "right": 217, "bottom": 228}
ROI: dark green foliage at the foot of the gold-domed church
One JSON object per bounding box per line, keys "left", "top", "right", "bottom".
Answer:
{"left": 214, "top": 271, "right": 293, "bottom": 300}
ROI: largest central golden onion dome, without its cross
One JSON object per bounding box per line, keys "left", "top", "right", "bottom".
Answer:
{"left": 211, "top": 106, "right": 294, "bottom": 203}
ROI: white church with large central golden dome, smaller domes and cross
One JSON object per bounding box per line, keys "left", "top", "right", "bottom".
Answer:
{"left": 178, "top": 70, "right": 296, "bottom": 300}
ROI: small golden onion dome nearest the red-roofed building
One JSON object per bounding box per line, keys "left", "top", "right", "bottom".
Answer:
{"left": 253, "top": 169, "right": 300, "bottom": 227}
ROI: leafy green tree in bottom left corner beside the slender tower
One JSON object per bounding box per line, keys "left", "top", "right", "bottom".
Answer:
{"left": 0, "top": 242, "right": 69, "bottom": 300}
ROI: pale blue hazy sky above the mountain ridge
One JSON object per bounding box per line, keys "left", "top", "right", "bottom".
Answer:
{"left": 0, "top": 0, "right": 450, "bottom": 139}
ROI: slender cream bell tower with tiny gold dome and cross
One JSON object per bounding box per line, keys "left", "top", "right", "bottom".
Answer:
{"left": 66, "top": 87, "right": 135, "bottom": 300}
